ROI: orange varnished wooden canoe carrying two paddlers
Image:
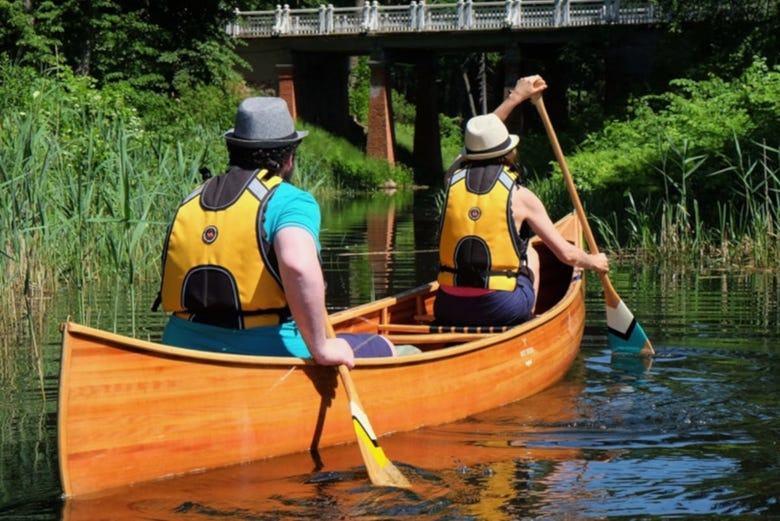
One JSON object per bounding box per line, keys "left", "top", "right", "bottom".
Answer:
{"left": 58, "top": 216, "right": 585, "bottom": 497}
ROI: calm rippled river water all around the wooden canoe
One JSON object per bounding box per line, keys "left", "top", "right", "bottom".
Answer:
{"left": 0, "top": 194, "right": 780, "bottom": 521}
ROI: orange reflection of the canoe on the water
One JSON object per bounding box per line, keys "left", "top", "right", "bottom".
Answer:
{"left": 61, "top": 378, "right": 585, "bottom": 521}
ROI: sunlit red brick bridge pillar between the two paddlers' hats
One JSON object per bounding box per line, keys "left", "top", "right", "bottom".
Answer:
{"left": 366, "top": 60, "right": 395, "bottom": 165}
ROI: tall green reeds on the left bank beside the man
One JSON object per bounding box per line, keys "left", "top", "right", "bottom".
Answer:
{"left": 0, "top": 64, "right": 210, "bottom": 334}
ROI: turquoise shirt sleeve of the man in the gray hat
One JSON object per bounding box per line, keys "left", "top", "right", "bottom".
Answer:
{"left": 263, "top": 182, "right": 321, "bottom": 252}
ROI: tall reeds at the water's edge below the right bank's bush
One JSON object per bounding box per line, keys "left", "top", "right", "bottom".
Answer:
{"left": 616, "top": 137, "right": 780, "bottom": 269}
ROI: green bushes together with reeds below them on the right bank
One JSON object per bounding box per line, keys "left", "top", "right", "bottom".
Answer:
{"left": 556, "top": 59, "right": 780, "bottom": 265}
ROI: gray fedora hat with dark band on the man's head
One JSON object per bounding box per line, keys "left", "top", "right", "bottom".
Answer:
{"left": 225, "top": 97, "right": 308, "bottom": 148}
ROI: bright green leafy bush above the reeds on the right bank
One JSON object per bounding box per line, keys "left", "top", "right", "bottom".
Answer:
{"left": 570, "top": 60, "right": 780, "bottom": 207}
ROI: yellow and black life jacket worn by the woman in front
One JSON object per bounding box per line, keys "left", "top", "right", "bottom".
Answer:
{"left": 438, "top": 164, "right": 527, "bottom": 291}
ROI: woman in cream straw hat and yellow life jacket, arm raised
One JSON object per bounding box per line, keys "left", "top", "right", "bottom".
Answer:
{"left": 434, "top": 75, "right": 609, "bottom": 326}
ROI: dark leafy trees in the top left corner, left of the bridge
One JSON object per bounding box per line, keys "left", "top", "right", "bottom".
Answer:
{"left": 0, "top": 0, "right": 246, "bottom": 93}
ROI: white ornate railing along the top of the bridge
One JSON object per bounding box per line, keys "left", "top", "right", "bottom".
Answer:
{"left": 226, "top": 0, "right": 663, "bottom": 38}
